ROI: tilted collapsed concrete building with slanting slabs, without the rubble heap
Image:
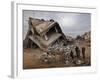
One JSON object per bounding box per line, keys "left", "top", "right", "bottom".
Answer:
{"left": 23, "top": 17, "right": 67, "bottom": 51}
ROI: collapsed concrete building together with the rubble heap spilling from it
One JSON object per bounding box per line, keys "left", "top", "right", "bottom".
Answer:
{"left": 23, "top": 17, "right": 88, "bottom": 65}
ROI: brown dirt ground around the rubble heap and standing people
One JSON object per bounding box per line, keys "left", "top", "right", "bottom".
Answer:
{"left": 23, "top": 41, "right": 91, "bottom": 69}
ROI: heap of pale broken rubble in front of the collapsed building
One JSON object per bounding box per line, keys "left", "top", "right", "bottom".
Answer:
{"left": 41, "top": 40, "right": 76, "bottom": 64}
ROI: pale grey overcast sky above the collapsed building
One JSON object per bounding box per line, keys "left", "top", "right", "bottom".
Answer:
{"left": 23, "top": 10, "right": 91, "bottom": 38}
